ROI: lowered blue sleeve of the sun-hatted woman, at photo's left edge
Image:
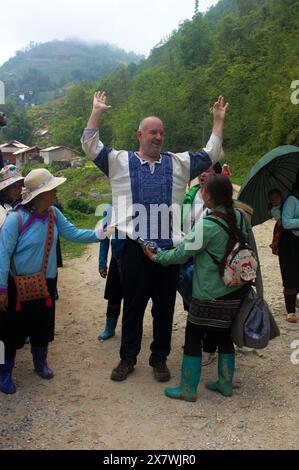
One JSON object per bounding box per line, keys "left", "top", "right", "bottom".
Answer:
{"left": 0, "top": 212, "right": 19, "bottom": 293}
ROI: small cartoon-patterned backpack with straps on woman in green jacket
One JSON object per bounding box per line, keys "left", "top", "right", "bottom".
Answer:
{"left": 206, "top": 212, "right": 258, "bottom": 287}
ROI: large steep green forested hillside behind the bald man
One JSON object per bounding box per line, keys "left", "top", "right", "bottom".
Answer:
{"left": 0, "top": 0, "right": 299, "bottom": 182}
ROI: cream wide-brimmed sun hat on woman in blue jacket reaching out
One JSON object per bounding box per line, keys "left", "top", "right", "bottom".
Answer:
{"left": 21, "top": 168, "right": 66, "bottom": 204}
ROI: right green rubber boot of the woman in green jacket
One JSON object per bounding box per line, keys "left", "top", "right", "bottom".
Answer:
{"left": 206, "top": 354, "right": 235, "bottom": 397}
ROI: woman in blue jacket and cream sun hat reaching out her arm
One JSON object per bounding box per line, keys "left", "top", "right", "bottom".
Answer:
{"left": 0, "top": 168, "right": 102, "bottom": 393}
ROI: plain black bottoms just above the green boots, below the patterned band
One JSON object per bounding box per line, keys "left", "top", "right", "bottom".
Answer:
{"left": 184, "top": 321, "right": 235, "bottom": 357}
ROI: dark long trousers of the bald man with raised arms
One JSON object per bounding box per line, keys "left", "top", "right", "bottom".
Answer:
{"left": 120, "top": 240, "right": 179, "bottom": 366}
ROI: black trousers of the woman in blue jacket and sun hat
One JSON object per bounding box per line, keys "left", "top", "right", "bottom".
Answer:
{"left": 0, "top": 277, "right": 56, "bottom": 359}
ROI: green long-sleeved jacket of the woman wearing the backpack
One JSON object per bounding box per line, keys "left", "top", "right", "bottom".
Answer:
{"left": 156, "top": 206, "right": 248, "bottom": 300}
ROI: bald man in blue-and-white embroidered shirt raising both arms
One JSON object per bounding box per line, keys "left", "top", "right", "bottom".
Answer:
{"left": 81, "top": 91, "right": 228, "bottom": 382}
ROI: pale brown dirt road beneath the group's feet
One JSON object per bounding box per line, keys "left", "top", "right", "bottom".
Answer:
{"left": 0, "top": 221, "right": 299, "bottom": 450}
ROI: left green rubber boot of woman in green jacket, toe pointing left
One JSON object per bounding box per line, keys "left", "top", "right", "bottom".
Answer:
{"left": 164, "top": 354, "right": 201, "bottom": 401}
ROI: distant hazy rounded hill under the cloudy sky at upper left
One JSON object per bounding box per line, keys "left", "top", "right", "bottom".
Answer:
{"left": 0, "top": 40, "right": 141, "bottom": 104}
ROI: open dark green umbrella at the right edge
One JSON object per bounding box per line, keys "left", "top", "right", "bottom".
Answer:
{"left": 238, "top": 145, "right": 299, "bottom": 225}
